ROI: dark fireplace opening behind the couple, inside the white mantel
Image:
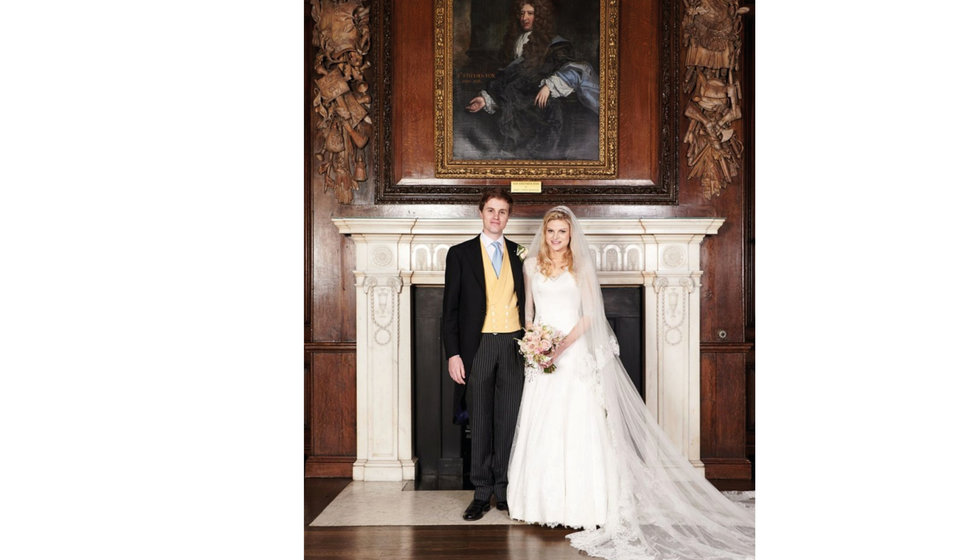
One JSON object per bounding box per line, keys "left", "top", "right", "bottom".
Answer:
{"left": 412, "top": 286, "right": 645, "bottom": 490}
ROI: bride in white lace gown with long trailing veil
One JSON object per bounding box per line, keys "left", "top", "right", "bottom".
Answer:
{"left": 507, "top": 206, "right": 755, "bottom": 560}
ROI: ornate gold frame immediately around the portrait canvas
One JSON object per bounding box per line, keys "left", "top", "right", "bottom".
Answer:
{"left": 435, "top": 0, "right": 619, "bottom": 179}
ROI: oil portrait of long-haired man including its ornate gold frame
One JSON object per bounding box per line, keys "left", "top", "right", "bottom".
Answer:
{"left": 434, "top": 0, "right": 619, "bottom": 179}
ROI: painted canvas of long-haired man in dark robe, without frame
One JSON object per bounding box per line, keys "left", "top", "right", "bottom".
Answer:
{"left": 452, "top": 0, "right": 600, "bottom": 161}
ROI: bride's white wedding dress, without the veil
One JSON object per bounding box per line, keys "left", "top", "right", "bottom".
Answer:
{"left": 507, "top": 271, "right": 612, "bottom": 529}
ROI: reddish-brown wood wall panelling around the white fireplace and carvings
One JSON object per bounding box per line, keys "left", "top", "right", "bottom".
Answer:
{"left": 305, "top": 0, "right": 755, "bottom": 484}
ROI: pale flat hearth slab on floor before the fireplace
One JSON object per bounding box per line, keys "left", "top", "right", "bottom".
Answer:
{"left": 310, "top": 481, "right": 755, "bottom": 527}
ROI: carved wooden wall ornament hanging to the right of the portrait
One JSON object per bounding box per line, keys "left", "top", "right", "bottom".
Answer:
{"left": 682, "top": 0, "right": 749, "bottom": 198}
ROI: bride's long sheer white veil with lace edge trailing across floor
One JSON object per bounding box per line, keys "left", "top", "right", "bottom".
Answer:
{"left": 529, "top": 206, "right": 755, "bottom": 560}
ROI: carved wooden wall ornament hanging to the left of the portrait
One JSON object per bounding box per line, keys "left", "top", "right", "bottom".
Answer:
{"left": 310, "top": 0, "right": 374, "bottom": 204}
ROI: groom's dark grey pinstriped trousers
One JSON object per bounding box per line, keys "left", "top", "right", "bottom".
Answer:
{"left": 466, "top": 331, "right": 524, "bottom": 501}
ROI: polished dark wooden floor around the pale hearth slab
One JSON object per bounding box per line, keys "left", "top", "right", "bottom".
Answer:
{"left": 303, "top": 478, "right": 588, "bottom": 560}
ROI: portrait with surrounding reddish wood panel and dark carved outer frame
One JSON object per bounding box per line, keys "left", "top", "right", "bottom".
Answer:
{"left": 369, "top": 0, "right": 684, "bottom": 204}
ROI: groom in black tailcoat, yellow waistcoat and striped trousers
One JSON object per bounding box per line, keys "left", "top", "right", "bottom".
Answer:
{"left": 442, "top": 188, "right": 524, "bottom": 521}
